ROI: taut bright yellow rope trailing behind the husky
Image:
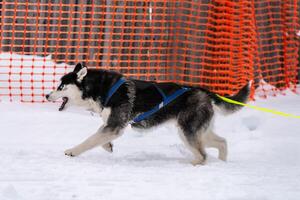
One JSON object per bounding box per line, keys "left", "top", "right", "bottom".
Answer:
{"left": 217, "top": 94, "right": 300, "bottom": 119}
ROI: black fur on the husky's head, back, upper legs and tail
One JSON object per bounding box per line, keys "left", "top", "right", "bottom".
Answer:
{"left": 52, "top": 64, "right": 250, "bottom": 163}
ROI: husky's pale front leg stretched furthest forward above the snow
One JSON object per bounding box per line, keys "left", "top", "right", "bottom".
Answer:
{"left": 65, "top": 126, "right": 121, "bottom": 156}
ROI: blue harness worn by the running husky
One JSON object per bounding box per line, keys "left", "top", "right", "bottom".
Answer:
{"left": 104, "top": 78, "right": 191, "bottom": 124}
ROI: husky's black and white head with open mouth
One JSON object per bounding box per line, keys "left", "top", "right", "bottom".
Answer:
{"left": 46, "top": 63, "right": 88, "bottom": 111}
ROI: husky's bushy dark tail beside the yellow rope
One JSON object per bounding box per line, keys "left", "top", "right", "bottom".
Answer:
{"left": 209, "top": 81, "right": 252, "bottom": 114}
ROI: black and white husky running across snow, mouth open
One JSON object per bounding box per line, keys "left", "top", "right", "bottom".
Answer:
{"left": 46, "top": 63, "right": 251, "bottom": 165}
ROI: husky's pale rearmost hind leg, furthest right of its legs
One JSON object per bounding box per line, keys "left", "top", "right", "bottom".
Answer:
{"left": 203, "top": 130, "right": 227, "bottom": 161}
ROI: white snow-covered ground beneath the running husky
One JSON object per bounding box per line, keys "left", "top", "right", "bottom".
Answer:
{"left": 0, "top": 90, "right": 300, "bottom": 200}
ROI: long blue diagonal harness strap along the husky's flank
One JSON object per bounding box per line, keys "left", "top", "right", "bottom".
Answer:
{"left": 129, "top": 87, "right": 191, "bottom": 124}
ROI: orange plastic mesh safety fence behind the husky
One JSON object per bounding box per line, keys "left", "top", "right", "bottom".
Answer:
{"left": 0, "top": 0, "right": 300, "bottom": 102}
